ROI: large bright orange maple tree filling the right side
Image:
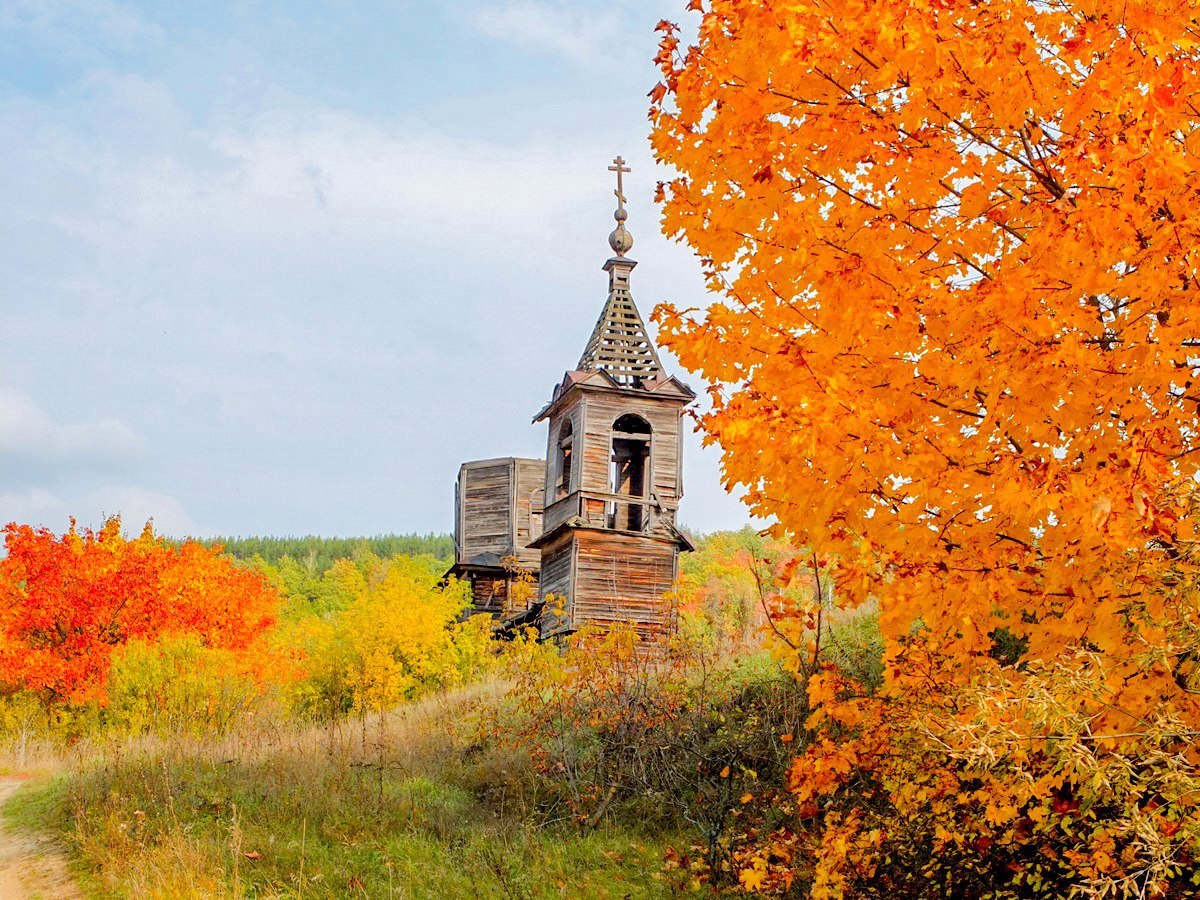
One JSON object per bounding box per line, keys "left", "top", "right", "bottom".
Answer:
{"left": 650, "top": 0, "right": 1200, "bottom": 894}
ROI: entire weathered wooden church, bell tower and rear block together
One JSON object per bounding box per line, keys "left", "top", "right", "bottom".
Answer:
{"left": 449, "top": 156, "right": 696, "bottom": 638}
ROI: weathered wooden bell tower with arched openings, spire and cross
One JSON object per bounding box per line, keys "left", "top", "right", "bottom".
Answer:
{"left": 530, "top": 156, "right": 696, "bottom": 638}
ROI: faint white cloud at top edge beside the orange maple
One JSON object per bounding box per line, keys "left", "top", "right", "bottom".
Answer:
{"left": 472, "top": 0, "right": 625, "bottom": 68}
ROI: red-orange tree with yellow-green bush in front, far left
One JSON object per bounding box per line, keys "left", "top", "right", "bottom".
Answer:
{"left": 0, "top": 518, "right": 281, "bottom": 758}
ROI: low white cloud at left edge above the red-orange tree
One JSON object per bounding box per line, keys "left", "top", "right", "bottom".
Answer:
{"left": 0, "top": 385, "right": 146, "bottom": 463}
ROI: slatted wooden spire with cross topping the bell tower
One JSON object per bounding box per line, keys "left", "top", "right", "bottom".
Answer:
{"left": 578, "top": 156, "right": 662, "bottom": 388}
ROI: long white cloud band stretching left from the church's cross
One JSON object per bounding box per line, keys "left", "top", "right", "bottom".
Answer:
{"left": 204, "top": 112, "right": 609, "bottom": 244}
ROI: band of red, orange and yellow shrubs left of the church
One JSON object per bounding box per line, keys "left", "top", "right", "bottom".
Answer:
{"left": 0, "top": 518, "right": 494, "bottom": 755}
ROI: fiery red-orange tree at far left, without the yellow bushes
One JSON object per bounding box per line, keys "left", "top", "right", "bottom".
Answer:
{"left": 0, "top": 517, "right": 278, "bottom": 702}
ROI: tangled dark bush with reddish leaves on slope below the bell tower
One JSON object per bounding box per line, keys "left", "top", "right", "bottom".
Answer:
{"left": 499, "top": 626, "right": 806, "bottom": 881}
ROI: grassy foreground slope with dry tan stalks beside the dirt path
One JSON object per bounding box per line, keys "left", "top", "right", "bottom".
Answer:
{"left": 10, "top": 685, "right": 691, "bottom": 900}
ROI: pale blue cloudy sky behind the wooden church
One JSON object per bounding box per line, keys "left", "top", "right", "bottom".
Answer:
{"left": 0, "top": 0, "right": 746, "bottom": 535}
